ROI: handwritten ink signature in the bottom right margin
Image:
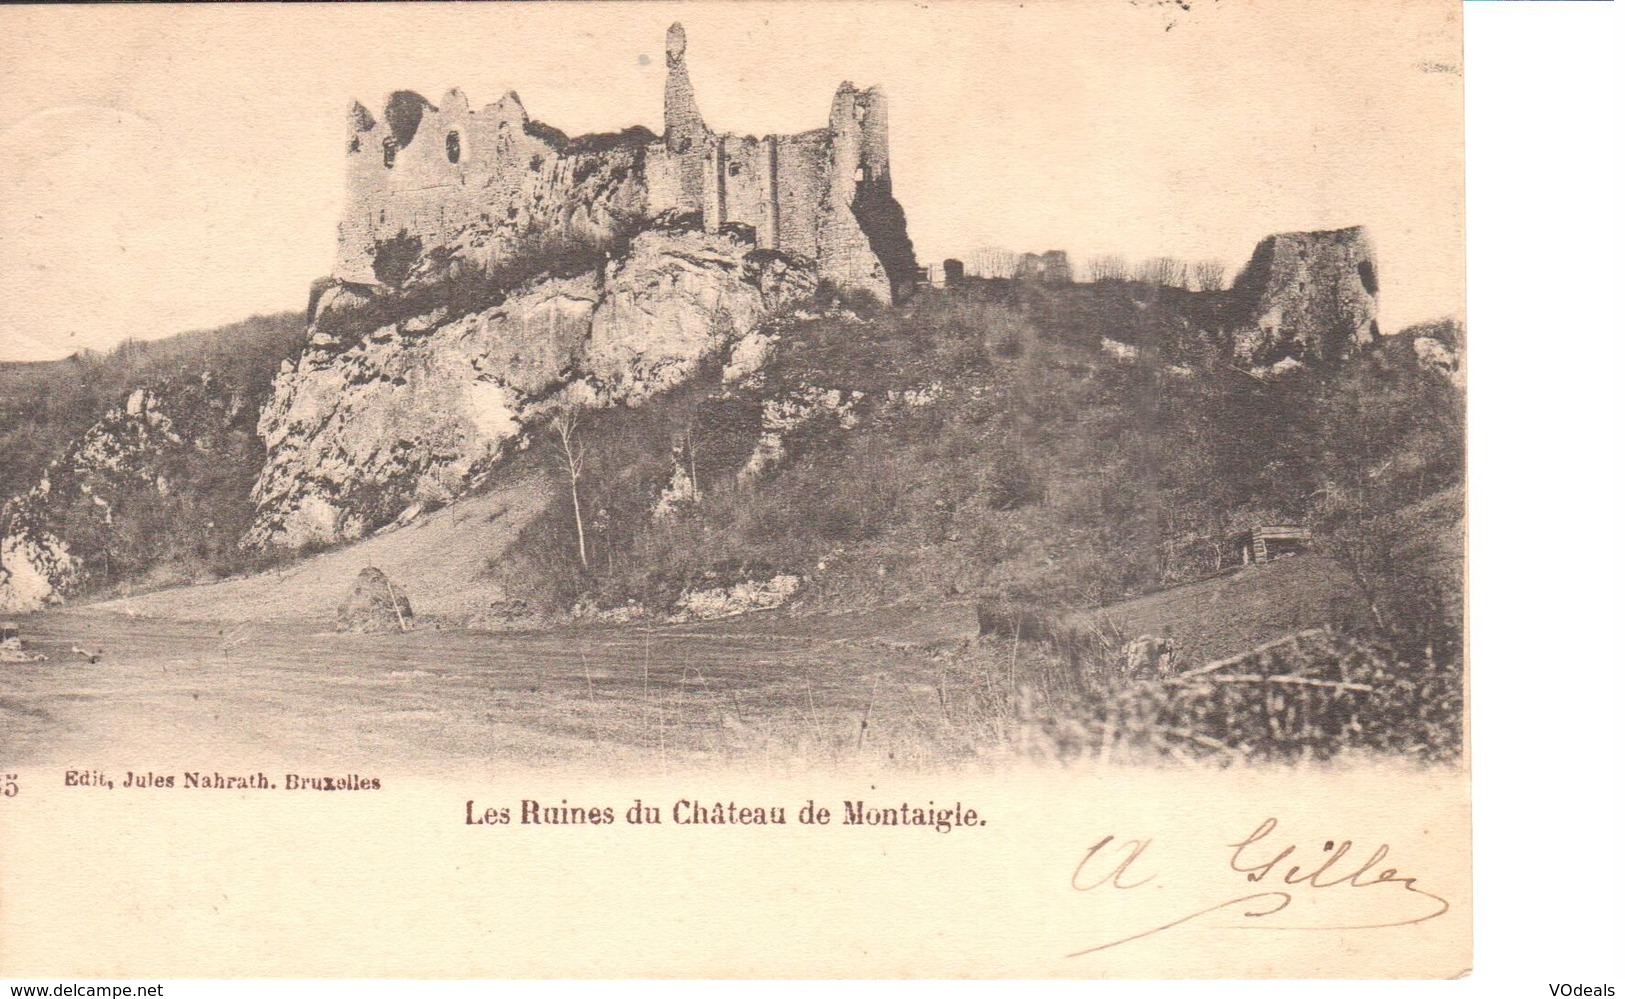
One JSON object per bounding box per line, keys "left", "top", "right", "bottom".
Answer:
{"left": 1066, "top": 819, "right": 1450, "bottom": 957}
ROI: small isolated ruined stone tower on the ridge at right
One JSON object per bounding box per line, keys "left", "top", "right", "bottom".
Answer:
{"left": 1232, "top": 226, "right": 1378, "bottom": 365}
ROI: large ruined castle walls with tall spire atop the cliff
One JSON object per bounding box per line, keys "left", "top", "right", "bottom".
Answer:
{"left": 333, "top": 24, "right": 915, "bottom": 302}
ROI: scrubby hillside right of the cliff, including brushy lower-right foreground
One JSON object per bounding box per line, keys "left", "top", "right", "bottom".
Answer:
{"left": 474, "top": 271, "right": 1464, "bottom": 759}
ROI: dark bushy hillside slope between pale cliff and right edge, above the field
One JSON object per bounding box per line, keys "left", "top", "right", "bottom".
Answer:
{"left": 492, "top": 283, "right": 1463, "bottom": 640}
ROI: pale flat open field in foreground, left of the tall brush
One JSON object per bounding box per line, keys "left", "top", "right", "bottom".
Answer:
{"left": 0, "top": 608, "right": 975, "bottom": 775}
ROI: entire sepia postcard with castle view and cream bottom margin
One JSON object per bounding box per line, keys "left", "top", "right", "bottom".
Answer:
{"left": 0, "top": 0, "right": 1527, "bottom": 978}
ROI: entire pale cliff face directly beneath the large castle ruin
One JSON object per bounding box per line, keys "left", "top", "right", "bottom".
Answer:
{"left": 244, "top": 226, "right": 814, "bottom": 547}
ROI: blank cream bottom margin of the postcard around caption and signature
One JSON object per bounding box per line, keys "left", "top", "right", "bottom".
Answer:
{"left": 0, "top": 5, "right": 1592, "bottom": 980}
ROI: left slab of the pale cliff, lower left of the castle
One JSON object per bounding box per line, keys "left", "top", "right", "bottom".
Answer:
{"left": 244, "top": 275, "right": 600, "bottom": 547}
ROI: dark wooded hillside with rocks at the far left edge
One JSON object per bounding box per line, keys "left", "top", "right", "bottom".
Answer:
{"left": 0, "top": 312, "right": 304, "bottom": 606}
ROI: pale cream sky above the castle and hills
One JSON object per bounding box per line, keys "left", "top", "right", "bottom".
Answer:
{"left": 0, "top": 0, "right": 1463, "bottom": 359}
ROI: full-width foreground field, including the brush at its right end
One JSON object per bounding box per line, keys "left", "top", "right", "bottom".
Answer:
{"left": 0, "top": 545, "right": 1459, "bottom": 773}
